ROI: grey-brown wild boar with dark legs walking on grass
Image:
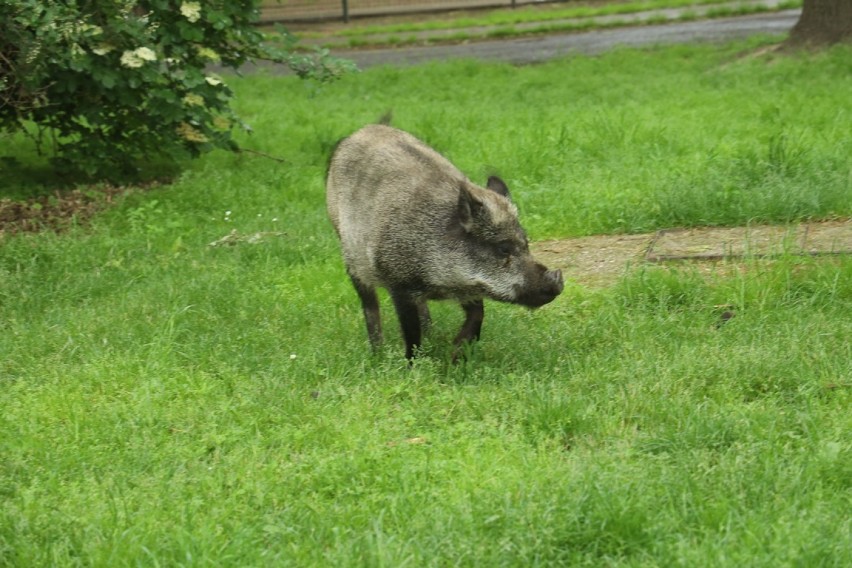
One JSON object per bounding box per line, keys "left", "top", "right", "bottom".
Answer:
{"left": 326, "top": 124, "right": 564, "bottom": 361}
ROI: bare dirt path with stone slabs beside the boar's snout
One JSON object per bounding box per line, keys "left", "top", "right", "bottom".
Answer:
{"left": 532, "top": 219, "right": 852, "bottom": 287}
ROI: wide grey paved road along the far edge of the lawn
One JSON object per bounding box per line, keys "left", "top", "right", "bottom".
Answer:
{"left": 333, "top": 10, "right": 801, "bottom": 69}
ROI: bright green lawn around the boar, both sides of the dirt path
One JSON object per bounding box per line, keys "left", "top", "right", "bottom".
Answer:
{"left": 0, "top": 39, "right": 852, "bottom": 567}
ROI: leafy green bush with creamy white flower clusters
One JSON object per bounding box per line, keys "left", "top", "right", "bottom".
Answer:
{"left": 0, "top": 0, "right": 348, "bottom": 177}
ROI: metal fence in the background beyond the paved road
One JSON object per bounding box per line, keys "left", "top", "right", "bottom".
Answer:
{"left": 261, "top": 0, "right": 558, "bottom": 23}
